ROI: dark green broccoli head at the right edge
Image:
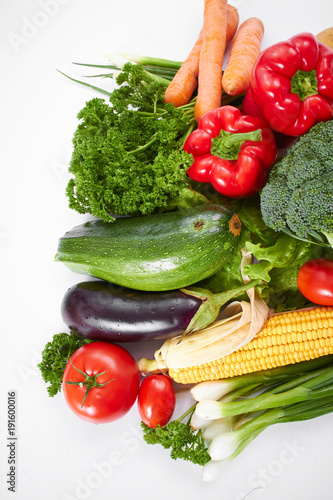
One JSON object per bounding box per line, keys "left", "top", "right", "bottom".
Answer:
{"left": 260, "top": 120, "right": 333, "bottom": 246}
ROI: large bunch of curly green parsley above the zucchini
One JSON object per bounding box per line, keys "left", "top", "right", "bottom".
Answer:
{"left": 66, "top": 63, "right": 198, "bottom": 222}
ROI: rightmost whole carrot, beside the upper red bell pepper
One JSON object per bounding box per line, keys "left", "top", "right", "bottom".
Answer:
{"left": 222, "top": 17, "right": 264, "bottom": 95}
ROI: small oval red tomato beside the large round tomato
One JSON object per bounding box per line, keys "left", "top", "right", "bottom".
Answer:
{"left": 138, "top": 375, "right": 176, "bottom": 429}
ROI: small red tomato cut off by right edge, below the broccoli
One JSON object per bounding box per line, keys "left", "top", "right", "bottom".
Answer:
{"left": 297, "top": 259, "right": 333, "bottom": 306}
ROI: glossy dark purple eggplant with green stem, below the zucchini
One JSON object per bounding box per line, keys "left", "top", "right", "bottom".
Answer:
{"left": 61, "top": 280, "right": 256, "bottom": 342}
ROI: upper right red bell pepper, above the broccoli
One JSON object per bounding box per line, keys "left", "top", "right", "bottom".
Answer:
{"left": 251, "top": 33, "right": 333, "bottom": 136}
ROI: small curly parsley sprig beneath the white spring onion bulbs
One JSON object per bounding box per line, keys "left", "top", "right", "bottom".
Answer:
{"left": 141, "top": 407, "right": 210, "bottom": 465}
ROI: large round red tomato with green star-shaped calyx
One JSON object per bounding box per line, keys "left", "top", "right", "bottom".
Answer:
{"left": 63, "top": 342, "right": 140, "bottom": 424}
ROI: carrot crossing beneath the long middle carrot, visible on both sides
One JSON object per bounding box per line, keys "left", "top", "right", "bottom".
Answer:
{"left": 164, "top": 5, "right": 239, "bottom": 108}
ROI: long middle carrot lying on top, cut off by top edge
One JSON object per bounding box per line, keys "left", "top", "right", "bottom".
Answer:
{"left": 194, "top": 0, "right": 227, "bottom": 121}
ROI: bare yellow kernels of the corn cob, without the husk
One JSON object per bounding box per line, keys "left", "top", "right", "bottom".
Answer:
{"left": 169, "top": 307, "right": 333, "bottom": 384}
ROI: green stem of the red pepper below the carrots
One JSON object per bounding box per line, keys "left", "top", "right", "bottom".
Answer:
{"left": 211, "top": 129, "right": 262, "bottom": 160}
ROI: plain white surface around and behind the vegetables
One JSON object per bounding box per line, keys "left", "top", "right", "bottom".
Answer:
{"left": 0, "top": 0, "right": 333, "bottom": 500}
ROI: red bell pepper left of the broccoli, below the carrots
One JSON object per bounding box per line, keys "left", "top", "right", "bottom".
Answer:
{"left": 184, "top": 106, "right": 277, "bottom": 198}
